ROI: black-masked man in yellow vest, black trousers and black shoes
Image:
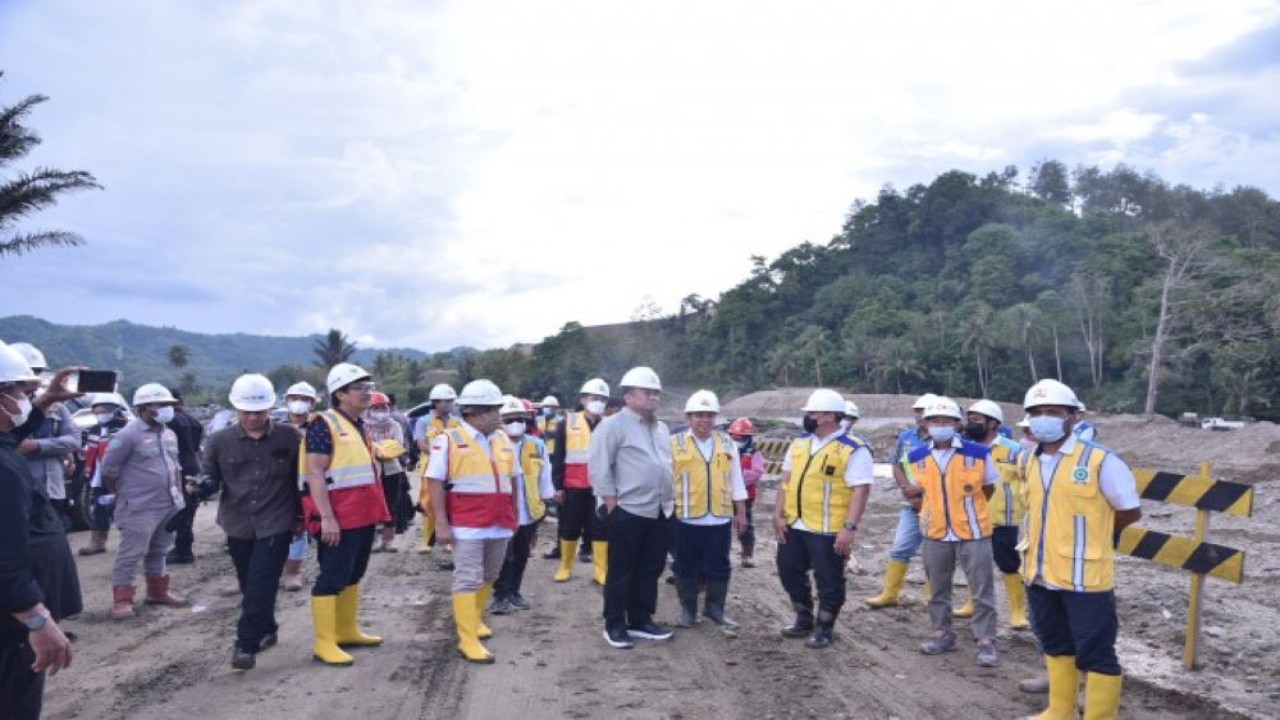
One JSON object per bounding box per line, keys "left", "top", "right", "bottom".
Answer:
{"left": 773, "top": 388, "right": 874, "bottom": 650}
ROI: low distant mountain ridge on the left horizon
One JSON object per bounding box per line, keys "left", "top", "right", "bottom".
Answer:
{"left": 0, "top": 315, "right": 430, "bottom": 388}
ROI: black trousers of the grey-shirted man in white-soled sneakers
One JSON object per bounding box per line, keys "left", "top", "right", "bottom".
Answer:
{"left": 604, "top": 507, "right": 671, "bottom": 628}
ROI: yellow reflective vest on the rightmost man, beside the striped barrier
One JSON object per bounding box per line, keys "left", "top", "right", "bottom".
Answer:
{"left": 1018, "top": 441, "right": 1115, "bottom": 592}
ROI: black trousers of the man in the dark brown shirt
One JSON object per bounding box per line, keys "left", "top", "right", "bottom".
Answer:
{"left": 227, "top": 530, "right": 293, "bottom": 653}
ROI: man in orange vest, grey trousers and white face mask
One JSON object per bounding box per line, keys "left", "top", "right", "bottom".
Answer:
{"left": 908, "top": 397, "right": 1000, "bottom": 667}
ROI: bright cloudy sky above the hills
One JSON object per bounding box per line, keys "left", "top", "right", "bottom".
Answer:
{"left": 0, "top": 0, "right": 1280, "bottom": 350}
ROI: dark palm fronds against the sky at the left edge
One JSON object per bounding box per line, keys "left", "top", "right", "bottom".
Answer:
{"left": 0, "top": 72, "right": 102, "bottom": 258}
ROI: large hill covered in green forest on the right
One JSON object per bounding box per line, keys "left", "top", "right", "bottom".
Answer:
{"left": 504, "top": 161, "right": 1280, "bottom": 419}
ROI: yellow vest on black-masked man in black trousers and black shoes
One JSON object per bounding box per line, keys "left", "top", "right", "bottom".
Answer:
{"left": 782, "top": 434, "right": 863, "bottom": 534}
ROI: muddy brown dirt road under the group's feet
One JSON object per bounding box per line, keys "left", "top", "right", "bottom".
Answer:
{"left": 46, "top": 466, "right": 1254, "bottom": 720}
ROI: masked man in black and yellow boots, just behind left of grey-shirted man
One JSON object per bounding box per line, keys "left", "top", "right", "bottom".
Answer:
{"left": 552, "top": 378, "right": 609, "bottom": 585}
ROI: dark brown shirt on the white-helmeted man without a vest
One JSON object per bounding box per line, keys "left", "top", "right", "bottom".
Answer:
{"left": 200, "top": 421, "right": 302, "bottom": 539}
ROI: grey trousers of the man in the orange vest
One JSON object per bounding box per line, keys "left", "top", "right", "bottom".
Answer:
{"left": 923, "top": 538, "right": 996, "bottom": 641}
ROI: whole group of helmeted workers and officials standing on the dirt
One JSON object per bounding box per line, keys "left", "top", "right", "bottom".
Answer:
{"left": 0, "top": 330, "right": 1140, "bottom": 717}
